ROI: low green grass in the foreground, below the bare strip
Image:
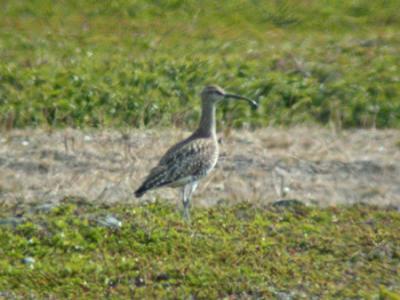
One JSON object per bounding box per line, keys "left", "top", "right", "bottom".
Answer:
{"left": 0, "top": 199, "right": 400, "bottom": 299}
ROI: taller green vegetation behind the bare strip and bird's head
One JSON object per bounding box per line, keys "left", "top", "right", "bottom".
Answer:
{"left": 0, "top": 0, "right": 400, "bottom": 129}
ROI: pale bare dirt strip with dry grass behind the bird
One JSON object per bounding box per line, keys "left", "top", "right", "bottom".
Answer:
{"left": 0, "top": 127, "right": 400, "bottom": 206}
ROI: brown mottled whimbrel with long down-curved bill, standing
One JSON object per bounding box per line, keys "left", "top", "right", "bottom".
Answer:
{"left": 135, "top": 85, "right": 258, "bottom": 219}
